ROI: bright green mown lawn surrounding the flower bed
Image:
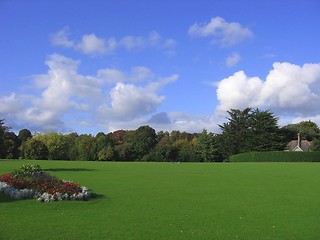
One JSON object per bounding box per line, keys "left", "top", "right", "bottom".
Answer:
{"left": 0, "top": 160, "right": 320, "bottom": 240}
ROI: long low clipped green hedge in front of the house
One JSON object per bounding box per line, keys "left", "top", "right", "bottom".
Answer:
{"left": 229, "top": 151, "right": 320, "bottom": 162}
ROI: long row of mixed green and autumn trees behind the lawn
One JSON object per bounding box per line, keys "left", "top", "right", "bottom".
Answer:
{"left": 0, "top": 108, "right": 320, "bottom": 162}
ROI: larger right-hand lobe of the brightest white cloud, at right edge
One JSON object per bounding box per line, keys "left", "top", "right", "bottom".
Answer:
{"left": 261, "top": 62, "right": 320, "bottom": 113}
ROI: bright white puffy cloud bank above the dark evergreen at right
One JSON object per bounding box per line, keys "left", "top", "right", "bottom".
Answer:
{"left": 216, "top": 62, "right": 320, "bottom": 119}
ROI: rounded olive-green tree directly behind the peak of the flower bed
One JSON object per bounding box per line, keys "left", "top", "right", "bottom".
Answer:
{"left": 23, "top": 138, "right": 49, "bottom": 160}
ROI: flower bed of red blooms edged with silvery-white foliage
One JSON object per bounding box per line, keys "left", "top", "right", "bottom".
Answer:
{"left": 0, "top": 165, "right": 91, "bottom": 202}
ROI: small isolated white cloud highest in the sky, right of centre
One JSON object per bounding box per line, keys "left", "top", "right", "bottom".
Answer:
{"left": 188, "top": 17, "right": 253, "bottom": 46}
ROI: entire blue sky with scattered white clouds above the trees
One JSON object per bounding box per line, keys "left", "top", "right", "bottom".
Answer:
{"left": 0, "top": 0, "right": 320, "bottom": 134}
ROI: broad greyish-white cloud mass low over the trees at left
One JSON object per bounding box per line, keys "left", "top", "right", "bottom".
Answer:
{"left": 0, "top": 54, "right": 178, "bottom": 132}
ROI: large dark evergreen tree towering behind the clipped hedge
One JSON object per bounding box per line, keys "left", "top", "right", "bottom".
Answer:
{"left": 219, "top": 108, "right": 286, "bottom": 157}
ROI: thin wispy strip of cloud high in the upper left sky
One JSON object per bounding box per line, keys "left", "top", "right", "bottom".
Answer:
{"left": 51, "top": 27, "right": 176, "bottom": 55}
